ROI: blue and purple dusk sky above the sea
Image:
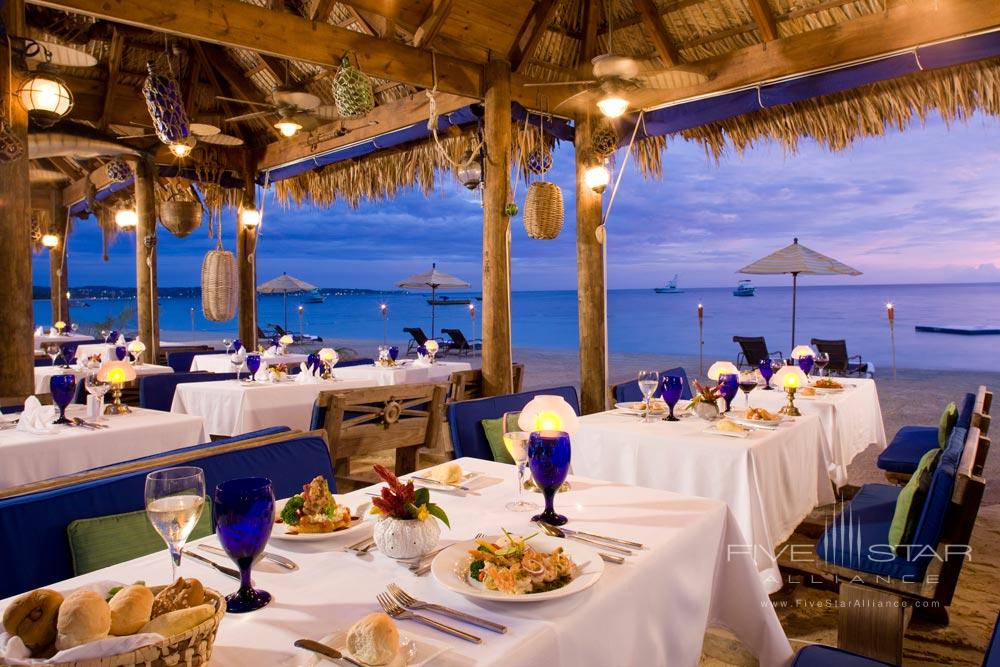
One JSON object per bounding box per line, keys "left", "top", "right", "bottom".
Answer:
{"left": 35, "top": 111, "right": 1000, "bottom": 290}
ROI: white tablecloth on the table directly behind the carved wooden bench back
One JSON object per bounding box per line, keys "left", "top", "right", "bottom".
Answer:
{"left": 170, "top": 379, "right": 371, "bottom": 436}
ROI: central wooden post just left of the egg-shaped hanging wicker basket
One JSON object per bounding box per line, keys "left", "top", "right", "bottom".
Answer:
{"left": 482, "top": 60, "right": 513, "bottom": 396}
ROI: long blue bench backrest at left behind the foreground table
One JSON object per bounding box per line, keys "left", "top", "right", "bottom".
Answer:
{"left": 0, "top": 434, "right": 334, "bottom": 598}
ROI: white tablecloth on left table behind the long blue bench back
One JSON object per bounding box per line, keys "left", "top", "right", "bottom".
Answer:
{"left": 0, "top": 405, "right": 207, "bottom": 488}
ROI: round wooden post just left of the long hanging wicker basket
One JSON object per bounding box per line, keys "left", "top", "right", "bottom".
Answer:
{"left": 135, "top": 157, "right": 160, "bottom": 364}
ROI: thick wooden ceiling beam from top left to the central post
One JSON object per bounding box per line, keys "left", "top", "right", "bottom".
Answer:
{"left": 31, "top": 0, "right": 483, "bottom": 97}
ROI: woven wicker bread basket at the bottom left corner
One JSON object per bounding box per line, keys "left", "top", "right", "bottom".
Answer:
{"left": 59, "top": 586, "right": 226, "bottom": 667}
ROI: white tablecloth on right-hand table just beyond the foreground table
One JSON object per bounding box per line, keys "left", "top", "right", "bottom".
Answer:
{"left": 573, "top": 411, "right": 834, "bottom": 593}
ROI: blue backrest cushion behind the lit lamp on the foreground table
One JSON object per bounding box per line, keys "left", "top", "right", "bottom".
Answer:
{"left": 448, "top": 386, "right": 580, "bottom": 461}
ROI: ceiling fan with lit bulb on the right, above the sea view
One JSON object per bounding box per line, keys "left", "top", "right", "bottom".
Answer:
{"left": 524, "top": 53, "right": 708, "bottom": 118}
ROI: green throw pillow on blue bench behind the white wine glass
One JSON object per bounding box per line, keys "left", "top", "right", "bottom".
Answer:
{"left": 66, "top": 498, "right": 213, "bottom": 575}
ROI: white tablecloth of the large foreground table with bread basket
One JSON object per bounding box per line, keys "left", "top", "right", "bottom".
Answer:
{"left": 0, "top": 459, "right": 792, "bottom": 667}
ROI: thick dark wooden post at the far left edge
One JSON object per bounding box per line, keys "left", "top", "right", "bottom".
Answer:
{"left": 0, "top": 0, "right": 35, "bottom": 397}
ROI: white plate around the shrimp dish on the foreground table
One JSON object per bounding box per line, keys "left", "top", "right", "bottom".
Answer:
{"left": 431, "top": 535, "right": 604, "bottom": 602}
